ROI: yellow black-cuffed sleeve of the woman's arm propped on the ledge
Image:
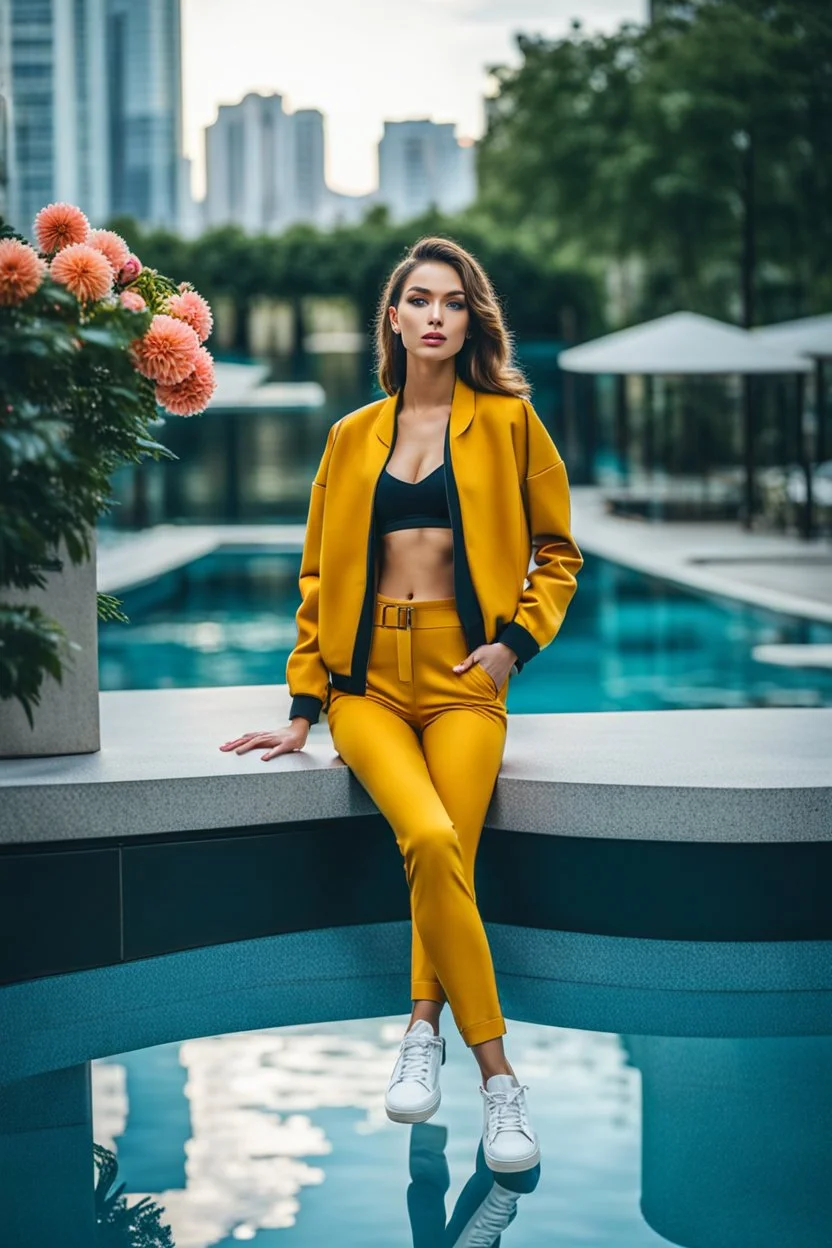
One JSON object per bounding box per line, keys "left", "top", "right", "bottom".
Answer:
{"left": 286, "top": 421, "right": 341, "bottom": 724}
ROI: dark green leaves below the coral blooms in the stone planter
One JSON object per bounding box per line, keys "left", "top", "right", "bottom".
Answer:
{"left": 0, "top": 214, "right": 175, "bottom": 723}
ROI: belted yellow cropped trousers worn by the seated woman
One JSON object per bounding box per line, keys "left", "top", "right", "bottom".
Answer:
{"left": 328, "top": 594, "right": 509, "bottom": 1045}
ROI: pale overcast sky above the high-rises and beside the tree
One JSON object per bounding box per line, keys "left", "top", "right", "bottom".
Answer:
{"left": 182, "top": 0, "right": 646, "bottom": 197}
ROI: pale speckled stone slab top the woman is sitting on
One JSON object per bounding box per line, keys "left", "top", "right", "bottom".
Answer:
{"left": 0, "top": 685, "right": 832, "bottom": 845}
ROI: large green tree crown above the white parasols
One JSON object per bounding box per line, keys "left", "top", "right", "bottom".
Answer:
{"left": 479, "top": 0, "right": 832, "bottom": 319}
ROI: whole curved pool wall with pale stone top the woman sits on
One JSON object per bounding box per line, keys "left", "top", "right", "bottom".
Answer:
{"left": 0, "top": 686, "right": 832, "bottom": 1068}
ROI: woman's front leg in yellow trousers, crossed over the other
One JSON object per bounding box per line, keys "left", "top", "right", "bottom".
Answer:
{"left": 328, "top": 694, "right": 505, "bottom": 1045}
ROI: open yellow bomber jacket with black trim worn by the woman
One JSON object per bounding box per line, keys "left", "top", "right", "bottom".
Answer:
{"left": 286, "top": 377, "right": 584, "bottom": 724}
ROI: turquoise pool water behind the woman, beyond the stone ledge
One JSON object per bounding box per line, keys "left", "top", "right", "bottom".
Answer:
{"left": 99, "top": 549, "right": 832, "bottom": 713}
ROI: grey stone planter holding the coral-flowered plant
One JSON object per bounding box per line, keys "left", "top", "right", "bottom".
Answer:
{"left": 0, "top": 534, "right": 101, "bottom": 759}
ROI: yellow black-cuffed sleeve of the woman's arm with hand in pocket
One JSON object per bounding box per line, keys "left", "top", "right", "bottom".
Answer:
{"left": 496, "top": 402, "right": 584, "bottom": 664}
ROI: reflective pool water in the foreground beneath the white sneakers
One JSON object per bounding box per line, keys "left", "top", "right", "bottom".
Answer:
{"left": 92, "top": 1017, "right": 832, "bottom": 1248}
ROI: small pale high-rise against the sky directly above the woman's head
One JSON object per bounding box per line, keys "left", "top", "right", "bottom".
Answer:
{"left": 378, "top": 120, "right": 476, "bottom": 221}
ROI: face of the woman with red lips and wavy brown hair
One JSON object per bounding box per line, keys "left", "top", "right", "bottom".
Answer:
{"left": 389, "top": 260, "right": 470, "bottom": 359}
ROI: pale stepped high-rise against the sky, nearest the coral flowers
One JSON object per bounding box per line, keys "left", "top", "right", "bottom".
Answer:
{"left": 203, "top": 91, "right": 327, "bottom": 233}
